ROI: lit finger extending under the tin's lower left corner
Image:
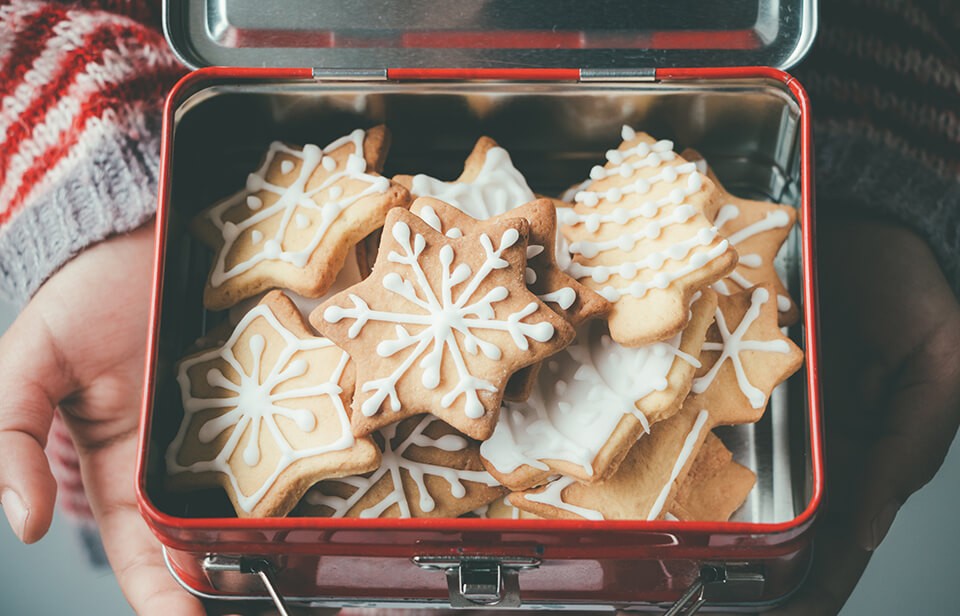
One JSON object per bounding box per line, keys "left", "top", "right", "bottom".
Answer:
{"left": 73, "top": 432, "right": 204, "bottom": 616}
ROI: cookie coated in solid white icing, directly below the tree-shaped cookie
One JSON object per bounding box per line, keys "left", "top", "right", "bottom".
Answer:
{"left": 480, "top": 290, "right": 717, "bottom": 490}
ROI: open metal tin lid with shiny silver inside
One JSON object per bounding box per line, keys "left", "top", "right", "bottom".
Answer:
{"left": 164, "top": 0, "right": 817, "bottom": 70}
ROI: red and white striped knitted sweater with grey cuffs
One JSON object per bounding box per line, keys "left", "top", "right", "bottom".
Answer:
{"left": 0, "top": 0, "right": 960, "bottom": 544}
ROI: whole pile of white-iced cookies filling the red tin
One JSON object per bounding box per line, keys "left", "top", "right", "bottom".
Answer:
{"left": 166, "top": 127, "right": 803, "bottom": 520}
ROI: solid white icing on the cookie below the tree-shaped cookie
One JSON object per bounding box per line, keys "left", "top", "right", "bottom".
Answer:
{"left": 480, "top": 322, "right": 700, "bottom": 476}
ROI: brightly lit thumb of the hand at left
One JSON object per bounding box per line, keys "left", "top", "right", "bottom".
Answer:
{"left": 0, "top": 303, "right": 70, "bottom": 543}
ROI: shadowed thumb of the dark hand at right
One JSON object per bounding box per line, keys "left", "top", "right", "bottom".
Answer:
{"left": 856, "top": 320, "right": 960, "bottom": 551}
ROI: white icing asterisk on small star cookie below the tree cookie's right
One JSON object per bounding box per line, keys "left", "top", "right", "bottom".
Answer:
{"left": 691, "top": 287, "right": 790, "bottom": 409}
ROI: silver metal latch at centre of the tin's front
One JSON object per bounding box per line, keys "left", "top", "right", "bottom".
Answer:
{"left": 413, "top": 556, "right": 540, "bottom": 608}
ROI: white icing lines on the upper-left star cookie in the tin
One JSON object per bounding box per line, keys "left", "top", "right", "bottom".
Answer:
{"left": 206, "top": 130, "right": 390, "bottom": 287}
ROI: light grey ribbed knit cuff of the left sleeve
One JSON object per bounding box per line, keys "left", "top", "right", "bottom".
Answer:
{"left": 0, "top": 111, "right": 160, "bottom": 306}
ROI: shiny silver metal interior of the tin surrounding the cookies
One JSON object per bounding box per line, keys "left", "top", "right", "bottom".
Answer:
{"left": 148, "top": 80, "right": 812, "bottom": 522}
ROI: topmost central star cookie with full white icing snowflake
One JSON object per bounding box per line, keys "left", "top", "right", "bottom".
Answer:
{"left": 310, "top": 208, "right": 573, "bottom": 440}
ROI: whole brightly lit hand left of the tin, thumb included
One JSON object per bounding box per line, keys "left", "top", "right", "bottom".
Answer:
{"left": 0, "top": 222, "right": 204, "bottom": 616}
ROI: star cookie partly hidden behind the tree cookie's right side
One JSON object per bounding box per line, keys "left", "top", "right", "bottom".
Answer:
{"left": 682, "top": 150, "right": 800, "bottom": 326}
